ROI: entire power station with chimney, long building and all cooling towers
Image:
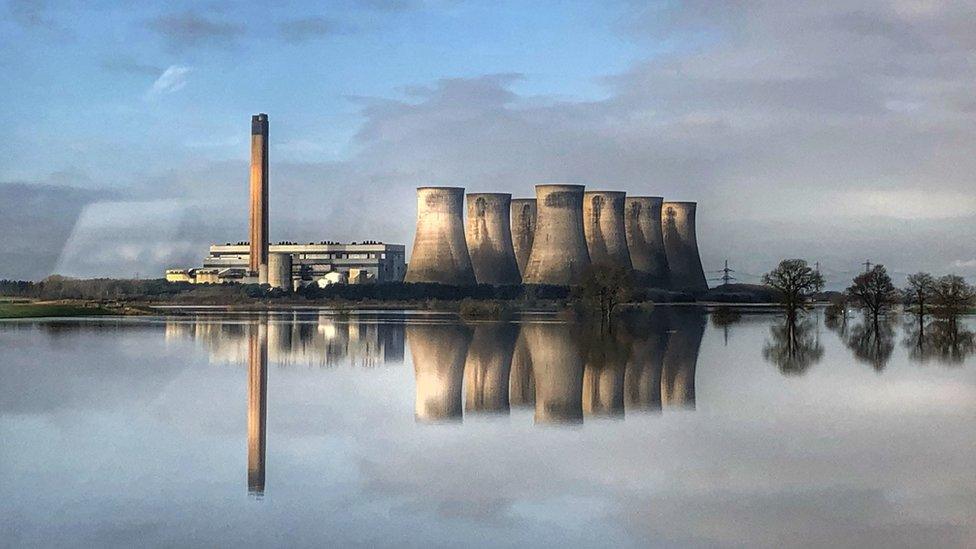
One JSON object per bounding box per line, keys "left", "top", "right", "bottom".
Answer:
{"left": 166, "top": 113, "right": 708, "bottom": 293}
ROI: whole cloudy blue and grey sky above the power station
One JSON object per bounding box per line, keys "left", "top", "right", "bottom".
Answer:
{"left": 0, "top": 0, "right": 976, "bottom": 287}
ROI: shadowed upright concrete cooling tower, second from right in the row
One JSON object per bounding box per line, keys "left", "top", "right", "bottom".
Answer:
{"left": 624, "top": 196, "right": 669, "bottom": 288}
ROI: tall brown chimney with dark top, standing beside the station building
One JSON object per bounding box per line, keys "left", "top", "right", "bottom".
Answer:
{"left": 250, "top": 113, "right": 268, "bottom": 284}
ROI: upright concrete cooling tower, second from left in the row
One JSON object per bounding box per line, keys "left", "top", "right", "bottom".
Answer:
{"left": 465, "top": 193, "right": 522, "bottom": 284}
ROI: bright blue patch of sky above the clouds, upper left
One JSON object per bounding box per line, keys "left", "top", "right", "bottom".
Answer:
{"left": 0, "top": 1, "right": 639, "bottom": 186}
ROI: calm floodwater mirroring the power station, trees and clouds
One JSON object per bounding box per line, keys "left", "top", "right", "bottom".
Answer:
{"left": 0, "top": 307, "right": 976, "bottom": 547}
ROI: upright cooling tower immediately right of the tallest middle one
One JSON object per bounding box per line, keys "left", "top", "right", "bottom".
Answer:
{"left": 583, "top": 191, "right": 631, "bottom": 269}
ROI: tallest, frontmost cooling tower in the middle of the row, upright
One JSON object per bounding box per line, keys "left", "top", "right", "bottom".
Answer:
{"left": 522, "top": 185, "right": 590, "bottom": 286}
